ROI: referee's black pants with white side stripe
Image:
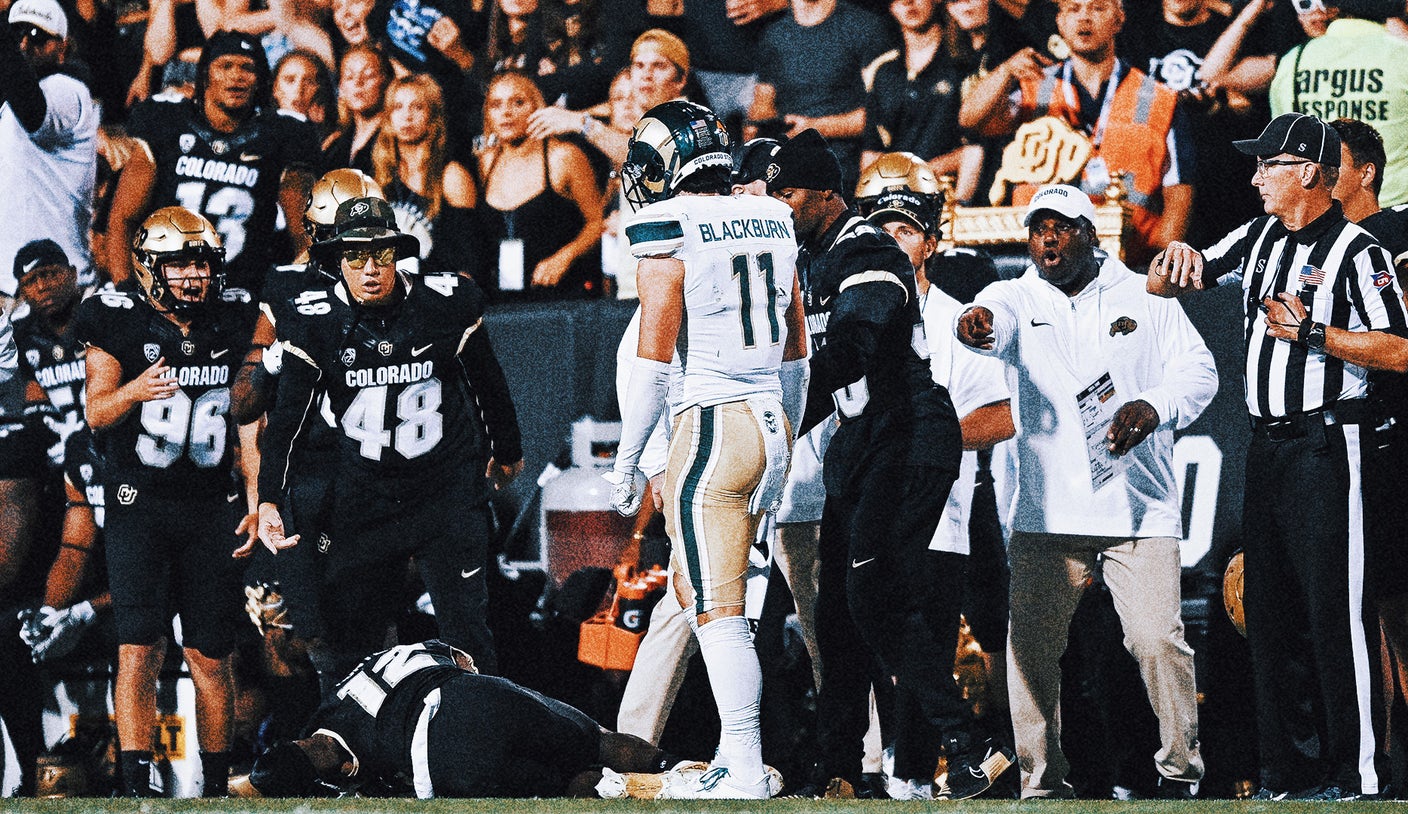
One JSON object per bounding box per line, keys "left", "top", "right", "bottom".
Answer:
{"left": 1242, "top": 414, "right": 1387, "bottom": 794}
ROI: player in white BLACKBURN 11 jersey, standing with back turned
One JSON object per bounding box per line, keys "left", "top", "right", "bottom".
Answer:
{"left": 608, "top": 101, "right": 807, "bottom": 799}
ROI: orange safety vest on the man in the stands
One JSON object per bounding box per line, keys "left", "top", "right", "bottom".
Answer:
{"left": 1012, "top": 68, "right": 1178, "bottom": 262}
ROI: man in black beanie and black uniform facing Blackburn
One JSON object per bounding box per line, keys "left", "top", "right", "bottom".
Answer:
{"left": 763, "top": 130, "right": 979, "bottom": 797}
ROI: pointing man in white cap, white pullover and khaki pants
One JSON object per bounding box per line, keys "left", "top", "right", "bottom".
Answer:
{"left": 956, "top": 186, "right": 1218, "bottom": 797}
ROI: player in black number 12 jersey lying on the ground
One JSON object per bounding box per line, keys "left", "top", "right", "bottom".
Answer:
{"left": 249, "top": 639, "right": 704, "bottom": 799}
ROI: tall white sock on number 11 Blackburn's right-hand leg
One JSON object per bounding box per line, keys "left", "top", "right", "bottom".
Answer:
{"left": 696, "top": 617, "right": 765, "bottom": 783}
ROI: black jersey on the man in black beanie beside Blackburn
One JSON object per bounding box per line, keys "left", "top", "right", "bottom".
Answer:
{"left": 797, "top": 213, "right": 957, "bottom": 452}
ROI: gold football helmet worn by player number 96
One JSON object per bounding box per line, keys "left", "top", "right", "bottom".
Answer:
{"left": 132, "top": 207, "right": 225, "bottom": 311}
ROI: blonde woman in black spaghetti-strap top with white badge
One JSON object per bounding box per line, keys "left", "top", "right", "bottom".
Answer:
{"left": 479, "top": 72, "right": 601, "bottom": 299}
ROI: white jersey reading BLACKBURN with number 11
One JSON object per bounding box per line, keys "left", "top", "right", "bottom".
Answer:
{"left": 625, "top": 196, "right": 797, "bottom": 413}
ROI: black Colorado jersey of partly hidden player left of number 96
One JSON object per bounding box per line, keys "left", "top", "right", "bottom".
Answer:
{"left": 14, "top": 301, "right": 87, "bottom": 466}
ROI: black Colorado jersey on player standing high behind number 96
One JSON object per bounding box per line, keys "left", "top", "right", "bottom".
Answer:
{"left": 127, "top": 101, "right": 318, "bottom": 292}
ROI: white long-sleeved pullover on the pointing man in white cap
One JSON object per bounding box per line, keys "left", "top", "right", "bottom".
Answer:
{"left": 973, "top": 252, "right": 1218, "bottom": 538}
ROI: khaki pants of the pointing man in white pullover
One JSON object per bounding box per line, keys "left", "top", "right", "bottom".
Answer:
{"left": 1007, "top": 531, "right": 1202, "bottom": 797}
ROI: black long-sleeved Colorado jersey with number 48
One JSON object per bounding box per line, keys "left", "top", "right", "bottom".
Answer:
{"left": 259, "top": 268, "right": 522, "bottom": 503}
